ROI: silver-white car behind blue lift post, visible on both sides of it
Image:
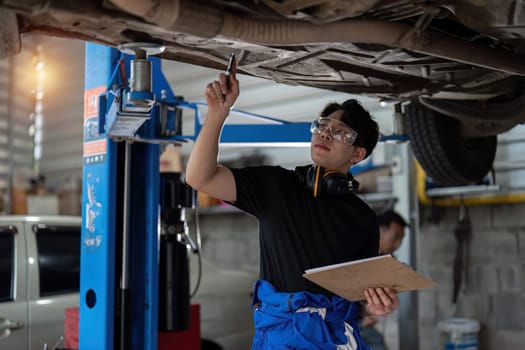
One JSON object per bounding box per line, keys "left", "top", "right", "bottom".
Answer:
{"left": 0, "top": 216, "right": 257, "bottom": 350}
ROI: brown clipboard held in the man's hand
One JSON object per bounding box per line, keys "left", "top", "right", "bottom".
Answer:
{"left": 303, "top": 254, "right": 436, "bottom": 301}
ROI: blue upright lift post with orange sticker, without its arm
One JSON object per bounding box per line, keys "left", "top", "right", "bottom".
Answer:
{"left": 79, "top": 44, "right": 159, "bottom": 350}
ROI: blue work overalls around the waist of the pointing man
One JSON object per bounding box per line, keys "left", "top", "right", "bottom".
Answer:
{"left": 252, "top": 280, "right": 370, "bottom": 350}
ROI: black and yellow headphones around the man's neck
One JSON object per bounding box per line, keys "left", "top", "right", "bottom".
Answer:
{"left": 295, "top": 165, "right": 359, "bottom": 197}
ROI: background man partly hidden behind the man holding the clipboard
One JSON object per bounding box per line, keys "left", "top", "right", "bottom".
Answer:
{"left": 361, "top": 210, "right": 408, "bottom": 350}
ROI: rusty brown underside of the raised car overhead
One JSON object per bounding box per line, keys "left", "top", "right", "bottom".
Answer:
{"left": 0, "top": 0, "right": 525, "bottom": 99}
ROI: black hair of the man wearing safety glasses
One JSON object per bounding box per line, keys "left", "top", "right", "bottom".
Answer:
{"left": 320, "top": 99, "right": 379, "bottom": 158}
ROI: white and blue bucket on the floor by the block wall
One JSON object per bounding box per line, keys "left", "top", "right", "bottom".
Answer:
{"left": 438, "top": 318, "right": 480, "bottom": 350}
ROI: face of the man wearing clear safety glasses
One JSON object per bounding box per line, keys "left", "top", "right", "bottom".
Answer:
{"left": 310, "top": 110, "right": 362, "bottom": 173}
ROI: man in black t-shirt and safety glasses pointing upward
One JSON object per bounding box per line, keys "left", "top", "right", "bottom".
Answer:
{"left": 186, "top": 58, "right": 399, "bottom": 350}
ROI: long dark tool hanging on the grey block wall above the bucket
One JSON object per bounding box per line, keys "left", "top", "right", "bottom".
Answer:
{"left": 452, "top": 196, "right": 472, "bottom": 304}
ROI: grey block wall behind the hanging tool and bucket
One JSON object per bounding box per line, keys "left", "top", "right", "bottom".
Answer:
{"left": 417, "top": 204, "right": 525, "bottom": 350}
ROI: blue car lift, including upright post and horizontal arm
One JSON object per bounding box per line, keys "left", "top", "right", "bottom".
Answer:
{"left": 79, "top": 43, "right": 310, "bottom": 350}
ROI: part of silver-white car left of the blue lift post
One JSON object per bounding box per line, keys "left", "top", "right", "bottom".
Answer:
{"left": 0, "top": 216, "right": 80, "bottom": 350}
